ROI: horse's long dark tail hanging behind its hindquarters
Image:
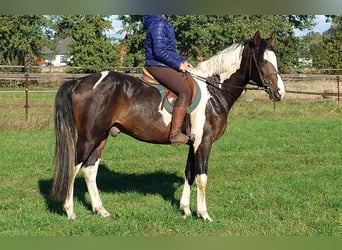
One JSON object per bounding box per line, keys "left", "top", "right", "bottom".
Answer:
{"left": 50, "top": 80, "right": 77, "bottom": 202}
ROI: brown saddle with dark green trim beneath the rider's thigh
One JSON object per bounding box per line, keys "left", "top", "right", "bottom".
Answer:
{"left": 142, "top": 68, "right": 200, "bottom": 109}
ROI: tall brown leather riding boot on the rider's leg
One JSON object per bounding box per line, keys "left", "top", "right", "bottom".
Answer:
{"left": 169, "top": 97, "right": 189, "bottom": 145}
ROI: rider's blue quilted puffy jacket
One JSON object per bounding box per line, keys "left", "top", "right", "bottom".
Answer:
{"left": 144, "top": 16, "right": 185, "bottom": 70}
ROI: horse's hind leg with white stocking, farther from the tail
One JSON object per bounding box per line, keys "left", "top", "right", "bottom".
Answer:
{"left": 81, "top": 140, "right": 110, "bottom": 217}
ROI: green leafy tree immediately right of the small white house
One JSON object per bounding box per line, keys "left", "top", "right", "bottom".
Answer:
{"left": 54, "top": 15, "right": 120, "bottom": 72}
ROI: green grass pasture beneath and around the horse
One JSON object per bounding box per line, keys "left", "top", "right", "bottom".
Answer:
{"left": 0, "top": 90, "right": 342, "bottom": 236}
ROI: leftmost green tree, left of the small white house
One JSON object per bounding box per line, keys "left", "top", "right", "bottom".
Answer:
{"left": 0, "top": 15, "right": 49, "bottom": 70}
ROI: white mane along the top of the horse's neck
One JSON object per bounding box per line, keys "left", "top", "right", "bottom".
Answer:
{"left": 191, "top": 43, "right": 244, "bottom": 82}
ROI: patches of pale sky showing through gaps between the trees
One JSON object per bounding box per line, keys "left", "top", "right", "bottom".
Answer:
{"left": 106, "top": 15, "right": 331, "bottom": 38}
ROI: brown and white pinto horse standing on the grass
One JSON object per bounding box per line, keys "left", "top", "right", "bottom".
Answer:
{"left": 51, "top": 32, "right": 285, "bottom": 221}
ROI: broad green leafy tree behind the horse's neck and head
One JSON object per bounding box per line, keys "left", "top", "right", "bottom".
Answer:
{"left": 174, "top": 15, "right": 313, "bottom": 72}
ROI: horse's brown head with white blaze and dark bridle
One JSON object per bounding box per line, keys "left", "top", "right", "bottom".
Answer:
{"left": 241, "top": 31, "right": 285, "bottom": 101}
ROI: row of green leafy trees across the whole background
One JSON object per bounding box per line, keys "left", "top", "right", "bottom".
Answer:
{"left": 0, "top": 15, "right": 342, "bottom": 73}
